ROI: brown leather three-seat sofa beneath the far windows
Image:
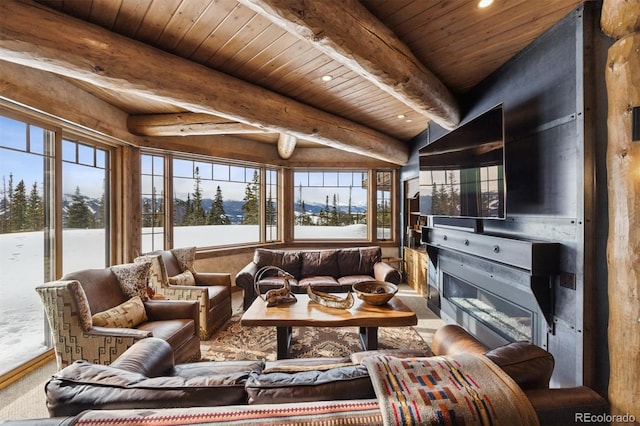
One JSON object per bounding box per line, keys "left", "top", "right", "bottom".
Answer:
{"left": 236, "top": 246, "right": 401, "bottom": 310}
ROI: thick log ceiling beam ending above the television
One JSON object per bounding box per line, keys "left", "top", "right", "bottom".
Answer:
{"left": 239, "top": 0, "right": 460, "bottom": 129}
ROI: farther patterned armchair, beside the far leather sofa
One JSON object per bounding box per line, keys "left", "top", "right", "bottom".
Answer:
{"left": 134, "top": 247, "right": 232, "bottom": 340}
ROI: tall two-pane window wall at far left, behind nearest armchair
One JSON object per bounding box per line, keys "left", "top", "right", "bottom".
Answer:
{"left": 0, "top": 114, "right": 110, "bottom": 376}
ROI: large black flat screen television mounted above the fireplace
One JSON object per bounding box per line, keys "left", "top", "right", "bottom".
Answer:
{"left": 419, "top": 104, "right": 506, "bottom": 219}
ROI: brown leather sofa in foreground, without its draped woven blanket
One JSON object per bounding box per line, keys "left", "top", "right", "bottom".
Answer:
{"left": 45, "top": 326, "right": 608, "bottom": 425}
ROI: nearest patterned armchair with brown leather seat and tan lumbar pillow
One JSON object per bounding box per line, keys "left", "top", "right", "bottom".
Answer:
{"left": 36, "top": 264, "right": 200, "bottom": 369}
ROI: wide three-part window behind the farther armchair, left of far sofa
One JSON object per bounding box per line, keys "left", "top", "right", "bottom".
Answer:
{"left": 141, "top": 154, "right": 280, "bottom": 252}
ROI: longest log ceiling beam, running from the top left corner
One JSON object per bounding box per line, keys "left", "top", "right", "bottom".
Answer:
{"left": 0, "top": 1, "right": 409, "bottom": 164}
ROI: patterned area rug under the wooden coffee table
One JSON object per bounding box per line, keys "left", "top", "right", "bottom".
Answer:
{"left": 201, "top": 314, "right": 429, "bottom": 361}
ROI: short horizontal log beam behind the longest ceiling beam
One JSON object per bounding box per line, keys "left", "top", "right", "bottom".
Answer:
{"left": 127, "top": 112, "right": 266, "bottom": 136}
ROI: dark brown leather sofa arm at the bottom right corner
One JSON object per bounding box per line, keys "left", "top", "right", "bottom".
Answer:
{"left": 524, "top": 386, "right": 609, "bottom": 426}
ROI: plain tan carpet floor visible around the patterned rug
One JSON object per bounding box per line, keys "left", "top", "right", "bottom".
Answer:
{"left": 0, "top": 284, "right": 444, "bottom": 422}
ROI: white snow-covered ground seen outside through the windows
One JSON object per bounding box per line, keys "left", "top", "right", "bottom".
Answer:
{"left": 0, "top": 225, "right": 367, "bottom": 374}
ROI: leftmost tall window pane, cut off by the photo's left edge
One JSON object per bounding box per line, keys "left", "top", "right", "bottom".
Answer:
{"left": 0, "top": 116, "right": 54, "bottom": 375}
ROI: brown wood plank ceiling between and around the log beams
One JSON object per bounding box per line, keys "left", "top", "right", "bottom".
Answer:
{"left": 15, "top": 0, "right": 582, "bottom": 164}
